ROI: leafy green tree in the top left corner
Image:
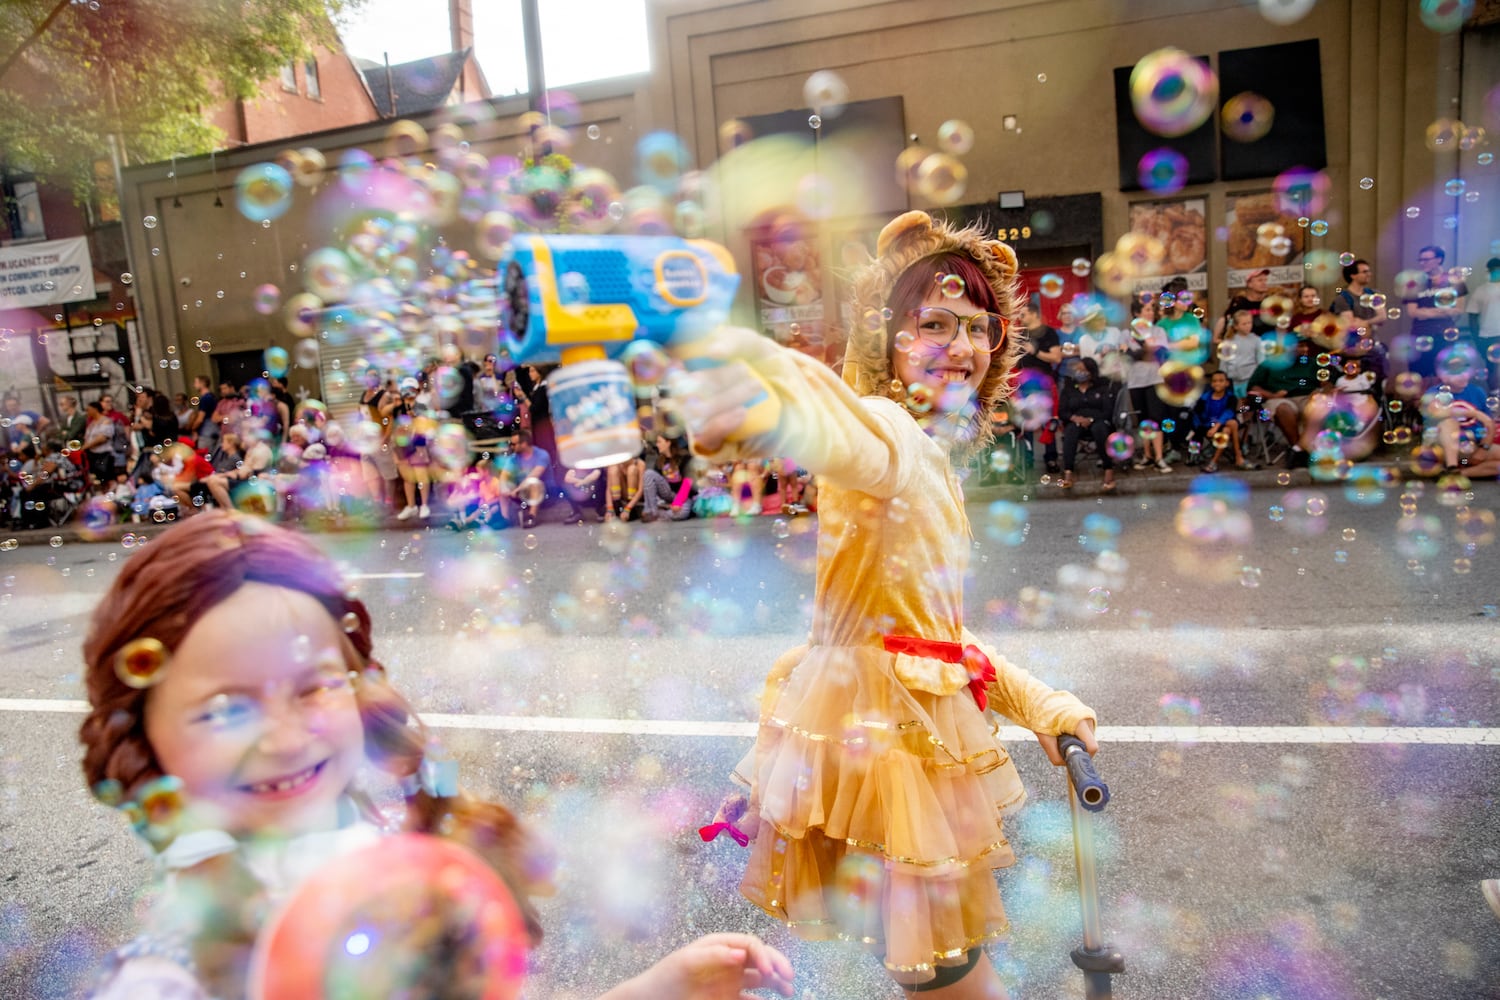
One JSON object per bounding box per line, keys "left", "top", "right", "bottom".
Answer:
{"left": 0, "top": 0, "right": 365, "bottom": 199}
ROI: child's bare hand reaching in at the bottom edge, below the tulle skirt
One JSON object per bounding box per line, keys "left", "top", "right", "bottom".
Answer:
{"left": 602, "top": 934, "right": 792, "bottom": 1000}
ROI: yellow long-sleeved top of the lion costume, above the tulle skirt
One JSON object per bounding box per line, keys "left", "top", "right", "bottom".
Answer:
{"left": 696, "top": 343, "right": 1095, "bottom": 735}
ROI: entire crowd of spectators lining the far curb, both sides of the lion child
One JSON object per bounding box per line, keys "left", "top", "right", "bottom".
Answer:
{"left": 0, "top": 247, "right": 1500, "bottom": 529}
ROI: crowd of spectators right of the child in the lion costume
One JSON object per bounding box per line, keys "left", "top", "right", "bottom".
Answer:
{"left": 978, "top": 246, "right": 1500, "bottom": 492}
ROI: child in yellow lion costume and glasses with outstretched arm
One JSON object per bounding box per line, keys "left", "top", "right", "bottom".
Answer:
{"left": 674, "top": 211, "right": 1095, "bottom": 1000}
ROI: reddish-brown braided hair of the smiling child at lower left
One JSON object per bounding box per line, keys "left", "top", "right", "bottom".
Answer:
{"left": 78, "top": 511, "right": 549, "bottom": 993}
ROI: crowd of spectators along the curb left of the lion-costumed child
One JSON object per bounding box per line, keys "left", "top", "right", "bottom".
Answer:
{"left": 0, "top": 355, "right": 816, "bottom": 529}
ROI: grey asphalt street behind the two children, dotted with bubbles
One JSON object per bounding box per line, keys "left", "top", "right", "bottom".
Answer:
{"left": 0, "top": 478, "right": 1500, "bottom": 1000}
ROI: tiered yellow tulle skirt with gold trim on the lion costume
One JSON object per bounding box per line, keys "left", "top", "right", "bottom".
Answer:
{"left": 737, "top": 646, "right": 1025, "bottom": 982}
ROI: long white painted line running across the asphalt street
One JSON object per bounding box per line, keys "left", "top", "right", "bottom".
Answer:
{"left": 0, "top": 699, "right": 1500, "bottom": 747}
